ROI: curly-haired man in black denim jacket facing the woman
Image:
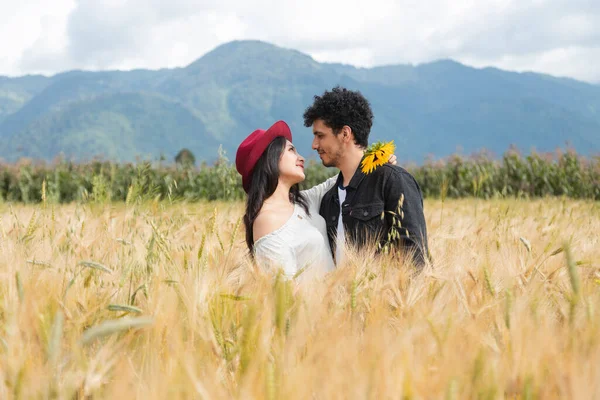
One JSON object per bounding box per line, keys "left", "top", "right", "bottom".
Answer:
{"left": 304, "top": 87, "right": 428, "bottom": 269}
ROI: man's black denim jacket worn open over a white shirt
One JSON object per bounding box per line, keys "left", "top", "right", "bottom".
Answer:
{"left": 319, "top": 164, "right": 428, "bottom": 267}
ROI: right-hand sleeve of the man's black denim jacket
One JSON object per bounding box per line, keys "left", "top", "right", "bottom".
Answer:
{"left": 384, "top": 171, "right": 429, "bottom": 269}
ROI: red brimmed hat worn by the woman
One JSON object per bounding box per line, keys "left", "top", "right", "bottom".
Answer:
{"left": 235, "top": 121, "right": 292, "bottom": 193}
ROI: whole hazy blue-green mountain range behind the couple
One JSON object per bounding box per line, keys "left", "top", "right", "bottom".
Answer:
{"left": 0, "top": 41, "right": 600, "bottom": 162}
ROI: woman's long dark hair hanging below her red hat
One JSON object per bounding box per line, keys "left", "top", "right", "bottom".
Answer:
{"left": 244, "top": 136, "right": 309, "bottom": 255}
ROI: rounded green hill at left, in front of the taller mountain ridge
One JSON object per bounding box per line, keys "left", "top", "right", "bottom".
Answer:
{"left": 5, "top": 93, "right": 219, "bottom": 160}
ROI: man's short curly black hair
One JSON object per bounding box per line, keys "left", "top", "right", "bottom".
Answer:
{"left": 304, "top": 86, "right": 373, "bottom": 147}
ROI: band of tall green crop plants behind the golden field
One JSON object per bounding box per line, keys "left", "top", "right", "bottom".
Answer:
{"left": 0, "top": 150, "right": 600, "bottom": 204}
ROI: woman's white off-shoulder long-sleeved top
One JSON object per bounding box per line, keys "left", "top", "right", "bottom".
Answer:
{"left": 254, "top": 176, "right": 337, "bottom": 279}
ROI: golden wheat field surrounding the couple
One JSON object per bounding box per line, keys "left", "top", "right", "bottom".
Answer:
{"left": 0, "top": 199, "right": 600, "bottom": 399}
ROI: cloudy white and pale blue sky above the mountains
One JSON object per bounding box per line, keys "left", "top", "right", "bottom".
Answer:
{"left": 0, "top": 0, "right": 600, "bottom": 82}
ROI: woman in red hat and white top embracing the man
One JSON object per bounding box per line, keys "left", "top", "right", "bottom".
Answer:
{"left": 236, "top": 121, "right": 395, "bottom": 278}
